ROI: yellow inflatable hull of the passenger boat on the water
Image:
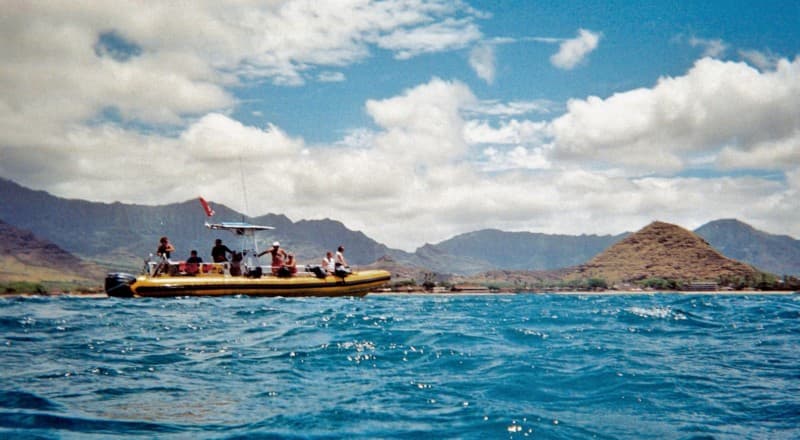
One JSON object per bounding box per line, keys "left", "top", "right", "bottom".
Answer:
{"left": 106, "top": 270, "right": 391, "bottom": 297}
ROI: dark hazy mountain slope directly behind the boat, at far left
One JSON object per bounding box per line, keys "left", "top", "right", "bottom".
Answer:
{"left": 0, "top": 179, "right": 400, "bottom": 270}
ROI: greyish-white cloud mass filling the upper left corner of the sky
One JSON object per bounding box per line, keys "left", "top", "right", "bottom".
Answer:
{"left": 0, "top": 0, "right": 480, "bottom": 134}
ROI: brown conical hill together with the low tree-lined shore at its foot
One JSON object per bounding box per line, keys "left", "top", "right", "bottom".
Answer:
{"left": 454, "top": 221, "right": 780, "bottom": 291}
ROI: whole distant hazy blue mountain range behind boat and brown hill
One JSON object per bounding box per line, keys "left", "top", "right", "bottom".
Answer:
{"left": 0, "top": 178, "right": 800, "bottom": 275}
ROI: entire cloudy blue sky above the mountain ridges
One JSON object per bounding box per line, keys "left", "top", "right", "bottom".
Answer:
{"left": 0, "top": 0, "right": 800, "bottom": 251}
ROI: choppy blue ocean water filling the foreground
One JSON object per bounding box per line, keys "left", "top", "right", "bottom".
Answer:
{"left": 0, "top": 294, "right": 800, "bottom": 439}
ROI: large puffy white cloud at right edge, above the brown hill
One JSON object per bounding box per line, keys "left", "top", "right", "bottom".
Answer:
{"left": 552, "top": 58, "right": 800, "bottom": 173}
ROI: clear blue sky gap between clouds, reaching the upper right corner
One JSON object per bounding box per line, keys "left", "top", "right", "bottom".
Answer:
{"left": 228, "top": 1, "right": 800, "bottom": 142}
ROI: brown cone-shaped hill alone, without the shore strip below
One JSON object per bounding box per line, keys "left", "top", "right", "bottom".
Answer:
{"left": 573, "top": 221, "right": 760, "bottom": 283}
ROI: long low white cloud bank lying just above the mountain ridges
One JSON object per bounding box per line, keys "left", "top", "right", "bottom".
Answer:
{"left": 0, "top": 73, "right": 800, "bottom": 250}
